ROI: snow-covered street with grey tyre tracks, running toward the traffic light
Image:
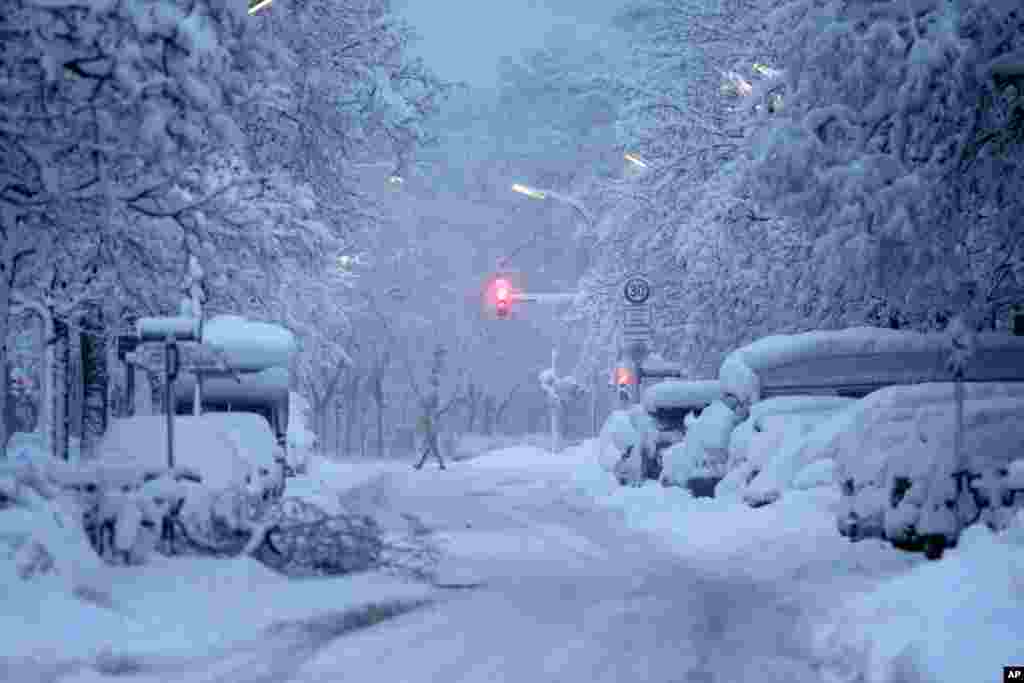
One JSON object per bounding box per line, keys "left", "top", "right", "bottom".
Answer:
{"left": 284, "top": 459, "right": 820, "bottom": 683}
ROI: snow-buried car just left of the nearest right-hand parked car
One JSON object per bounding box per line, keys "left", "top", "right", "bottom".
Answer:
{"left": 715, "top": 395, "right": 856, "bottom": 507}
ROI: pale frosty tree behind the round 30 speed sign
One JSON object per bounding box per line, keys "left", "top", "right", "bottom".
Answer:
{"left": 579, "top": 0, "right": 786, "bottom": 378}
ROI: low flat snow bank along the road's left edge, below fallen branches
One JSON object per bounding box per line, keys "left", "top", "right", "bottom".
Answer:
{"left": 0, "top": 557, "right": 431, "bottom": 681}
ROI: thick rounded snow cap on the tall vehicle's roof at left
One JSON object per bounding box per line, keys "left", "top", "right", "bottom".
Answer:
{"left": 203, "top": 315, "right": 296, "bottom": 372}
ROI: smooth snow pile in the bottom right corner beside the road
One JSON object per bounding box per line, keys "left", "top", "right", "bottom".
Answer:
{"left": 816, "top": 512, "right": 1024, "bottom": 683}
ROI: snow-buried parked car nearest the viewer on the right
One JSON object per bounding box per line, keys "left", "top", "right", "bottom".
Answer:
{"left": 805, "top": 383, "right": 1024, "bottom": 556}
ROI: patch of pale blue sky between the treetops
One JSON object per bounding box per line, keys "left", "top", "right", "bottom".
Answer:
{"left": 395, "top": 0, "right": 626, "bottom": 87}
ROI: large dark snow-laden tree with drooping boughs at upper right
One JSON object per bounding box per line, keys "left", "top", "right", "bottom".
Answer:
{"left": 748, "top": 0, "right": 1024, "bottom": 326}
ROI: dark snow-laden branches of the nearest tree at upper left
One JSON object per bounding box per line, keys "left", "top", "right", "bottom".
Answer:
{"left": 0, "top": 0, "right": 282, "bottom": 454}
